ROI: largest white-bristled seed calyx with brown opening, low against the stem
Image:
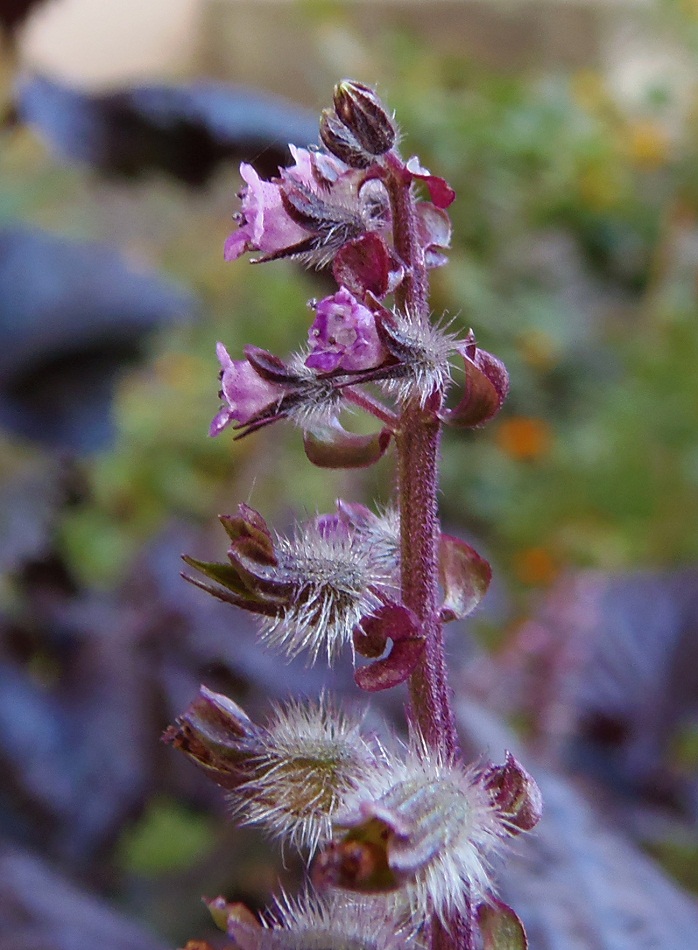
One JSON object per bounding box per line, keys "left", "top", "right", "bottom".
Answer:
{"left": 313, "top": 739, "right": 510, "bottom": 920}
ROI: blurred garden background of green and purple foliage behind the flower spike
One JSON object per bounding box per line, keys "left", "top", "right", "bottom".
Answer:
{"left": 0, "top": 0, "right": 698, "bottom": 950}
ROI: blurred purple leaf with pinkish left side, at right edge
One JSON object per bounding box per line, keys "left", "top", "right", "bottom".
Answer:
{"left": 486, "top": 569, "right": 698, "bottom": 815}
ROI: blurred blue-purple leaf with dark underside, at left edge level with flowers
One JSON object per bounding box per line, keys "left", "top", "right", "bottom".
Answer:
{"left": 0, "top": 227, "right": 197, "bottom": 450}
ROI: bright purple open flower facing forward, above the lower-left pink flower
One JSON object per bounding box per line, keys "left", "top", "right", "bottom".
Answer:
{"left": 305, "top": 287, "right": 388, "bottom": 373}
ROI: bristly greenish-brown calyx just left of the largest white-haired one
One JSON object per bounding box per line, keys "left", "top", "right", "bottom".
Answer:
{"left": 230, "top": 695, "right": 384, "bottom": 852}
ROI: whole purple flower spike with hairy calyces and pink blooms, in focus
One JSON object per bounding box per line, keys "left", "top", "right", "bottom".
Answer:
{"left": 166, "top": 81, "right": 541, "bottom": 950}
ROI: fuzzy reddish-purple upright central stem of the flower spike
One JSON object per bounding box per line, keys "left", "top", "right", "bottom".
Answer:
{"left": 385, "top": 153, "right": 474, "bottom": 950}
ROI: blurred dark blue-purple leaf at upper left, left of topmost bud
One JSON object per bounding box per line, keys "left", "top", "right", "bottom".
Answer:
{"left": 16, "top": 76, "right": 318, "bottom": 185}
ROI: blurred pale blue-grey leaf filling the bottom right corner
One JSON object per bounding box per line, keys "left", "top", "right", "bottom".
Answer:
{"left": 456, "top": 700, "right": 698, "bottom": 950}
